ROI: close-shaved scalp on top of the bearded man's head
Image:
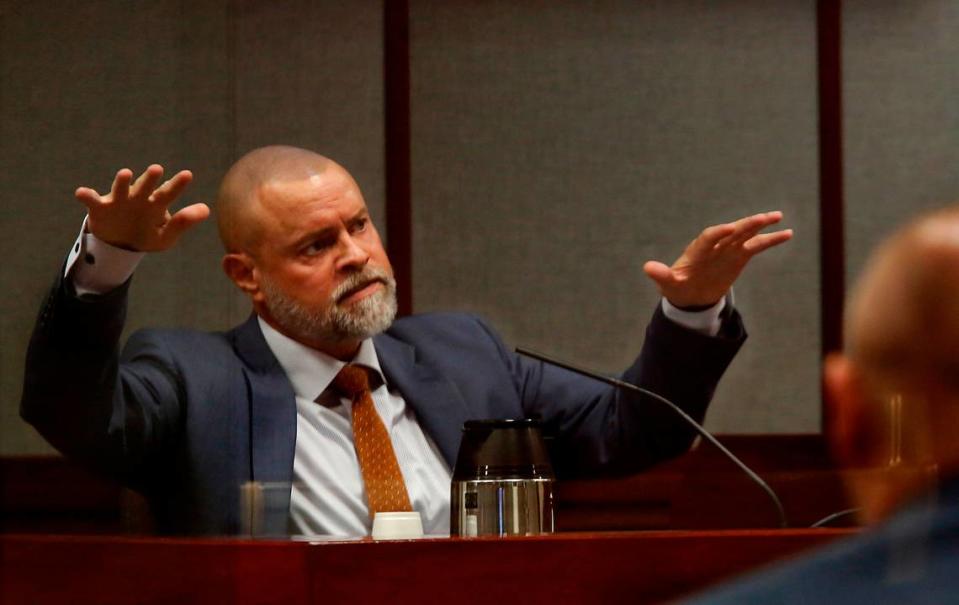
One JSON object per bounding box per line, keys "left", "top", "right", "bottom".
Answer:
{"left": 216, "top": 145, "right": 342, "bottom": 252}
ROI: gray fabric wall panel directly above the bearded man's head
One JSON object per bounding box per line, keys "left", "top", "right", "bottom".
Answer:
{"left": 235, "top": 0, "right": 386, "bottom": 238}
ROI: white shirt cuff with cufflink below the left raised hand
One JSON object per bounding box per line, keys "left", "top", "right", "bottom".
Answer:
{"left": 63, "top": 219, "right": 144, "bottom": 296}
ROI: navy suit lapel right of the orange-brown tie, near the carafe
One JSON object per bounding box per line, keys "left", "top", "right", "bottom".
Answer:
{"left": 373, "top": 333, "right": 471, "bottom": 468}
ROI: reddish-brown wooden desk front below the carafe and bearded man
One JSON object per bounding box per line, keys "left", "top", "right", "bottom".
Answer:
{"left": 0, "top": 529, "right": 853, "bottom": 605}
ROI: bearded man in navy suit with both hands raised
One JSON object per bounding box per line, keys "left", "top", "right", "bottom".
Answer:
{"left": 21, "top": 146, "right": 791, "bottom": 536}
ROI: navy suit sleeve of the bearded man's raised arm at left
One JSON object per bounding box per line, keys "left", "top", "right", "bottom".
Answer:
{"left": 20, "top": 277, "right": 178, "bottom": 484}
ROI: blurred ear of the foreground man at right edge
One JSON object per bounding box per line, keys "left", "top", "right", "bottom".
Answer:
{"left": 823, "top": 353, "right": 885, "bottom": 467}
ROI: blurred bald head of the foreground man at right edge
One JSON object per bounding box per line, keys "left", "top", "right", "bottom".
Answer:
{"left": 824, "top": 207, "right": 959, "bottom": 524}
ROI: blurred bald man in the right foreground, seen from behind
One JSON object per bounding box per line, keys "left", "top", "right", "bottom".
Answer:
{"left": 695, "top": 206, "right": 959, "bottom": 605}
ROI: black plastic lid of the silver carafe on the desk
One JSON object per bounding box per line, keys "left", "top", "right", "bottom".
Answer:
{"left": 453, "top": 418, "right": 554, "bottom": 480}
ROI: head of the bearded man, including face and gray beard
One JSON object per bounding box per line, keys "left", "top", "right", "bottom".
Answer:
{"left": 217, "top": 146, "right": 396, "bottom": 360}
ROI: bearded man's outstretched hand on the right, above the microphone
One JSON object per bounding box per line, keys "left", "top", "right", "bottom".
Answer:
{"left": 643, "top": 211, "right": 793, "bottom": 308}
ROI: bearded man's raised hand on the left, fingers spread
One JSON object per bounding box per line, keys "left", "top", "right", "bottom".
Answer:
{"left": 75, "top": 164, "right": 210, "bottom": 252}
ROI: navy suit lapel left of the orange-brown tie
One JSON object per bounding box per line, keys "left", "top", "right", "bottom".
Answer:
{"left": 236, "top": 315, "right": 296, "bottom": 490}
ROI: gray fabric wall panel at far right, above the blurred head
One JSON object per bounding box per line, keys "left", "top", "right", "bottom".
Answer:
{"left": 843, "top": 0, "right": 959, "bottom": 281}
